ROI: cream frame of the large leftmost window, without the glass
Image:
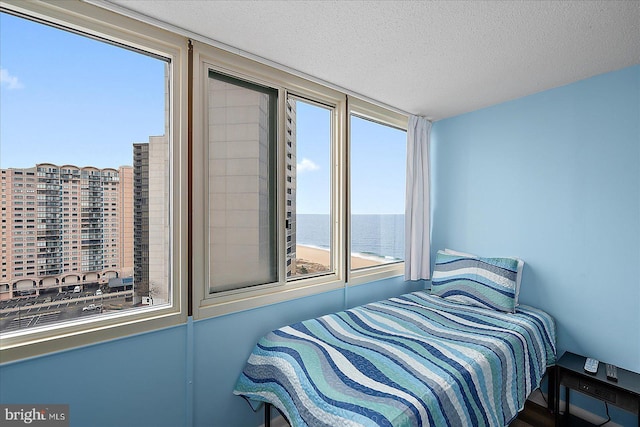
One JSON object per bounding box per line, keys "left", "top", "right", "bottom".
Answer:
{"left": 0, "top": 0, "right": 188, "bottom": 363}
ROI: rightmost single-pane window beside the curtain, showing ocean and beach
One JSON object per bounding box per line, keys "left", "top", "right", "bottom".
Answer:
{"left": 346, "top": 98, "right": 407, "bottom": 285}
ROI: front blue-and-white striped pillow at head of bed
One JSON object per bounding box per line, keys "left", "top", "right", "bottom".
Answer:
{"left": 431, "top": 251, "right": 518, "bottom": 313}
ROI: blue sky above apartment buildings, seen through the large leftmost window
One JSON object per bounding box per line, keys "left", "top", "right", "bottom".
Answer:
{"left": 0, "top": 13, "right": 165, "bottom": 168}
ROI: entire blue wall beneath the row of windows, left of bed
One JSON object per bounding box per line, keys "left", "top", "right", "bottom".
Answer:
{"left": 0, "top": 277, "right": 424, "bottom": 427}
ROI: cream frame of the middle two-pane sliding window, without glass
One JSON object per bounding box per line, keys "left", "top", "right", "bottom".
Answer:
{"left": 192, "top": 41, "right": 346, "bottom": 319}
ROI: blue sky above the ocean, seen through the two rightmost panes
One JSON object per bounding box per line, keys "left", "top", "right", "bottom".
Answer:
{"left": 296, "top": 102, "right": 406, "bottom": 214}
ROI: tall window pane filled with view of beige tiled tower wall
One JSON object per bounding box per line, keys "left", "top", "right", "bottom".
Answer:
{"left": 208, "top": 70, "right": 278, "bottom": 293}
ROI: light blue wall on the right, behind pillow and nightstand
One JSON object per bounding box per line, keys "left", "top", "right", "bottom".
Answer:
{"left": 431, "top": 66, "right": 640, "bottom": 422}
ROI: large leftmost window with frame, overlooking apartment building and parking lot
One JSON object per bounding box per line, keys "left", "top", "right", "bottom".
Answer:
{"left": 0, "top": 3, "right": 186, "bottom": 361}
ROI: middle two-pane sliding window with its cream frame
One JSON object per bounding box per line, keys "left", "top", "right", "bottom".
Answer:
{"left": 192, "top": 42, "right": 346, "bottom": 319}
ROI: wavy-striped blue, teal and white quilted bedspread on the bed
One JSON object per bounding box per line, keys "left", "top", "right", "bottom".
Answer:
{"left": 234, "top": 291, "right": 555, "bottom": 427}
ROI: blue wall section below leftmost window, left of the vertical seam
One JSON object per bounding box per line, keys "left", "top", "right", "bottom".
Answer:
{"left": 0, "top": 326, "right": 188, "bottom": 427}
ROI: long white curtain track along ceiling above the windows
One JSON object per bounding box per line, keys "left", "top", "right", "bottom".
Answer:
{"left": 81, "top": 0, "right": 412, "bottom": 117}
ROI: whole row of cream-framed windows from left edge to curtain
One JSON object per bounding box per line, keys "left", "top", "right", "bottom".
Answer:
{"left": 0, "top": 0, "right": 406, "bottom": 361}
